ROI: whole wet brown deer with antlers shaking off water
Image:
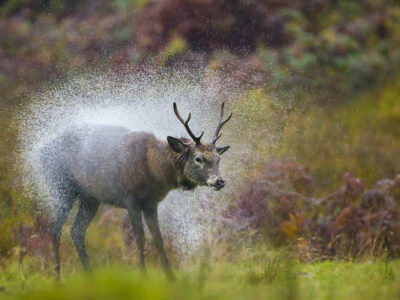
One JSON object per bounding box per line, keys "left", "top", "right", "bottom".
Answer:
{"left": 40, "top": 102, "right": 232, "bottom": 280}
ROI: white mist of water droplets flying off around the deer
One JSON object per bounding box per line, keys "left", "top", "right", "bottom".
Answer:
{"left": 18, "top": 71, "right": 242, "bottom": 262}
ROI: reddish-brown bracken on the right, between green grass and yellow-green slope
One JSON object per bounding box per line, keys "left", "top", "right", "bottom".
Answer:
{"left": 224, "top": 162, "right": 400, "bottom": 260}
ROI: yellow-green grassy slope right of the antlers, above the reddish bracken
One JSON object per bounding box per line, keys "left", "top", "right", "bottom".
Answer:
{"left": 225, "top": 80, "right": 400, "bottom": 195}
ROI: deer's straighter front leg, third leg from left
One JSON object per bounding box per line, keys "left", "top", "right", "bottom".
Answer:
{"left": 128, "top": 198, "right": 146, "bottom": 274}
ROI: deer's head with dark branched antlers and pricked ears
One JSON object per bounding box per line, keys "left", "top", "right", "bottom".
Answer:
{"left": 167, "top": 103, "right": 232, "bottom": 190}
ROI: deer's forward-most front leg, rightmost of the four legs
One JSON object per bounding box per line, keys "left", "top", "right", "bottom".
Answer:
{"left": 143, "top": 206, "right": 175, "bottom": 280}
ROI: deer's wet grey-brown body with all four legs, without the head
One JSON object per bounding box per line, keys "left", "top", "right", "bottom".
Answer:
{"left": 41, "top": 125, "right": 196, "bottom": 277}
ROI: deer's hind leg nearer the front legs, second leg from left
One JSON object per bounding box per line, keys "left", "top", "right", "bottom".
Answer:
{"left": 71, "top": 195, "right": 100, "bottom": 270}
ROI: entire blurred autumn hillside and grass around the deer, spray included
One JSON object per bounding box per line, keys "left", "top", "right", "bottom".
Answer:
{"left": 0, "top": 0, "right": 400, "bottom": 299}
